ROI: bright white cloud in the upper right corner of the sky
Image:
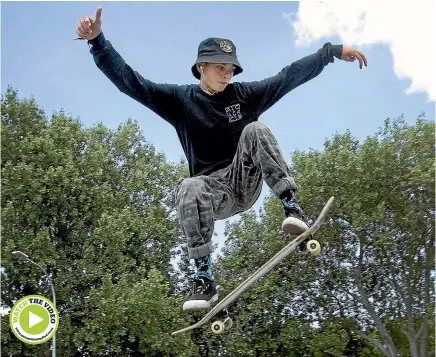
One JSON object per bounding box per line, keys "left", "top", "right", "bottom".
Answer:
{"left": 283, "top": 0, "right": 436, "bottom": 100}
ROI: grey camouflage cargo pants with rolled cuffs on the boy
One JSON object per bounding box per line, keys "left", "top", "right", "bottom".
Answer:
{"left": 175, "top": 122, "right": 297, "bottom": 259}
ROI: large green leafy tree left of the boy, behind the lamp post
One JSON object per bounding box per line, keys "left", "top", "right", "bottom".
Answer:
{"left": 1, "top": 88, "right": 196, "bottom": 356}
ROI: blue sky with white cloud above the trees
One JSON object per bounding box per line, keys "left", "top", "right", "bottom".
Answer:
{"left": 1, "top": 0, "right": 436, "bottom": 262}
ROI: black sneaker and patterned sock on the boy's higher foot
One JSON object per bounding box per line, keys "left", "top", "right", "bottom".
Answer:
{"left": 281, "top": 192, "right": 313, "bottom": 251}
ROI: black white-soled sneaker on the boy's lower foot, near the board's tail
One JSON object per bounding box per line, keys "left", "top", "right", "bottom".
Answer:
{"left": 183, "top": 276, "right": 219, "bottom": 311}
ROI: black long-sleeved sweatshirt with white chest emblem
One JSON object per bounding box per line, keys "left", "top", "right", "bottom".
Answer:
{"left": 89, "top": 33, "right": 342, "bottom": 176}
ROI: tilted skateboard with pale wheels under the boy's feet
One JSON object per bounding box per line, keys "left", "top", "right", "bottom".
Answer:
{"left": 171, "top": 196, "right": 334, "bottom": 336}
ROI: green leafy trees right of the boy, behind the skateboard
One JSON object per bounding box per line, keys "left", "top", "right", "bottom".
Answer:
{"left": 212, "top": 116, "right": 435, "bottom": 357}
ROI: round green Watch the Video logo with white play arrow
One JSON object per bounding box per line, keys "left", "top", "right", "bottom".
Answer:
{"left": 9, "top": 295, "right": 59, "bottom": 345}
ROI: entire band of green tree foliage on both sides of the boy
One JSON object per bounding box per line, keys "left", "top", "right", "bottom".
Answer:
{"left": 1, "top": 85, "right": 435, "bottom": 357}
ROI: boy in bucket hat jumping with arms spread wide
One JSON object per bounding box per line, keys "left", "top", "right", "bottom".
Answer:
{"left": 76, "top": 8, "right": 367, "bottom": 310}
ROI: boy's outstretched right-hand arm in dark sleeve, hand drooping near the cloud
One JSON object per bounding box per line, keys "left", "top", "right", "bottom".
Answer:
{"left": 243, "top": 42, "right": 367, "bottom": 115}
